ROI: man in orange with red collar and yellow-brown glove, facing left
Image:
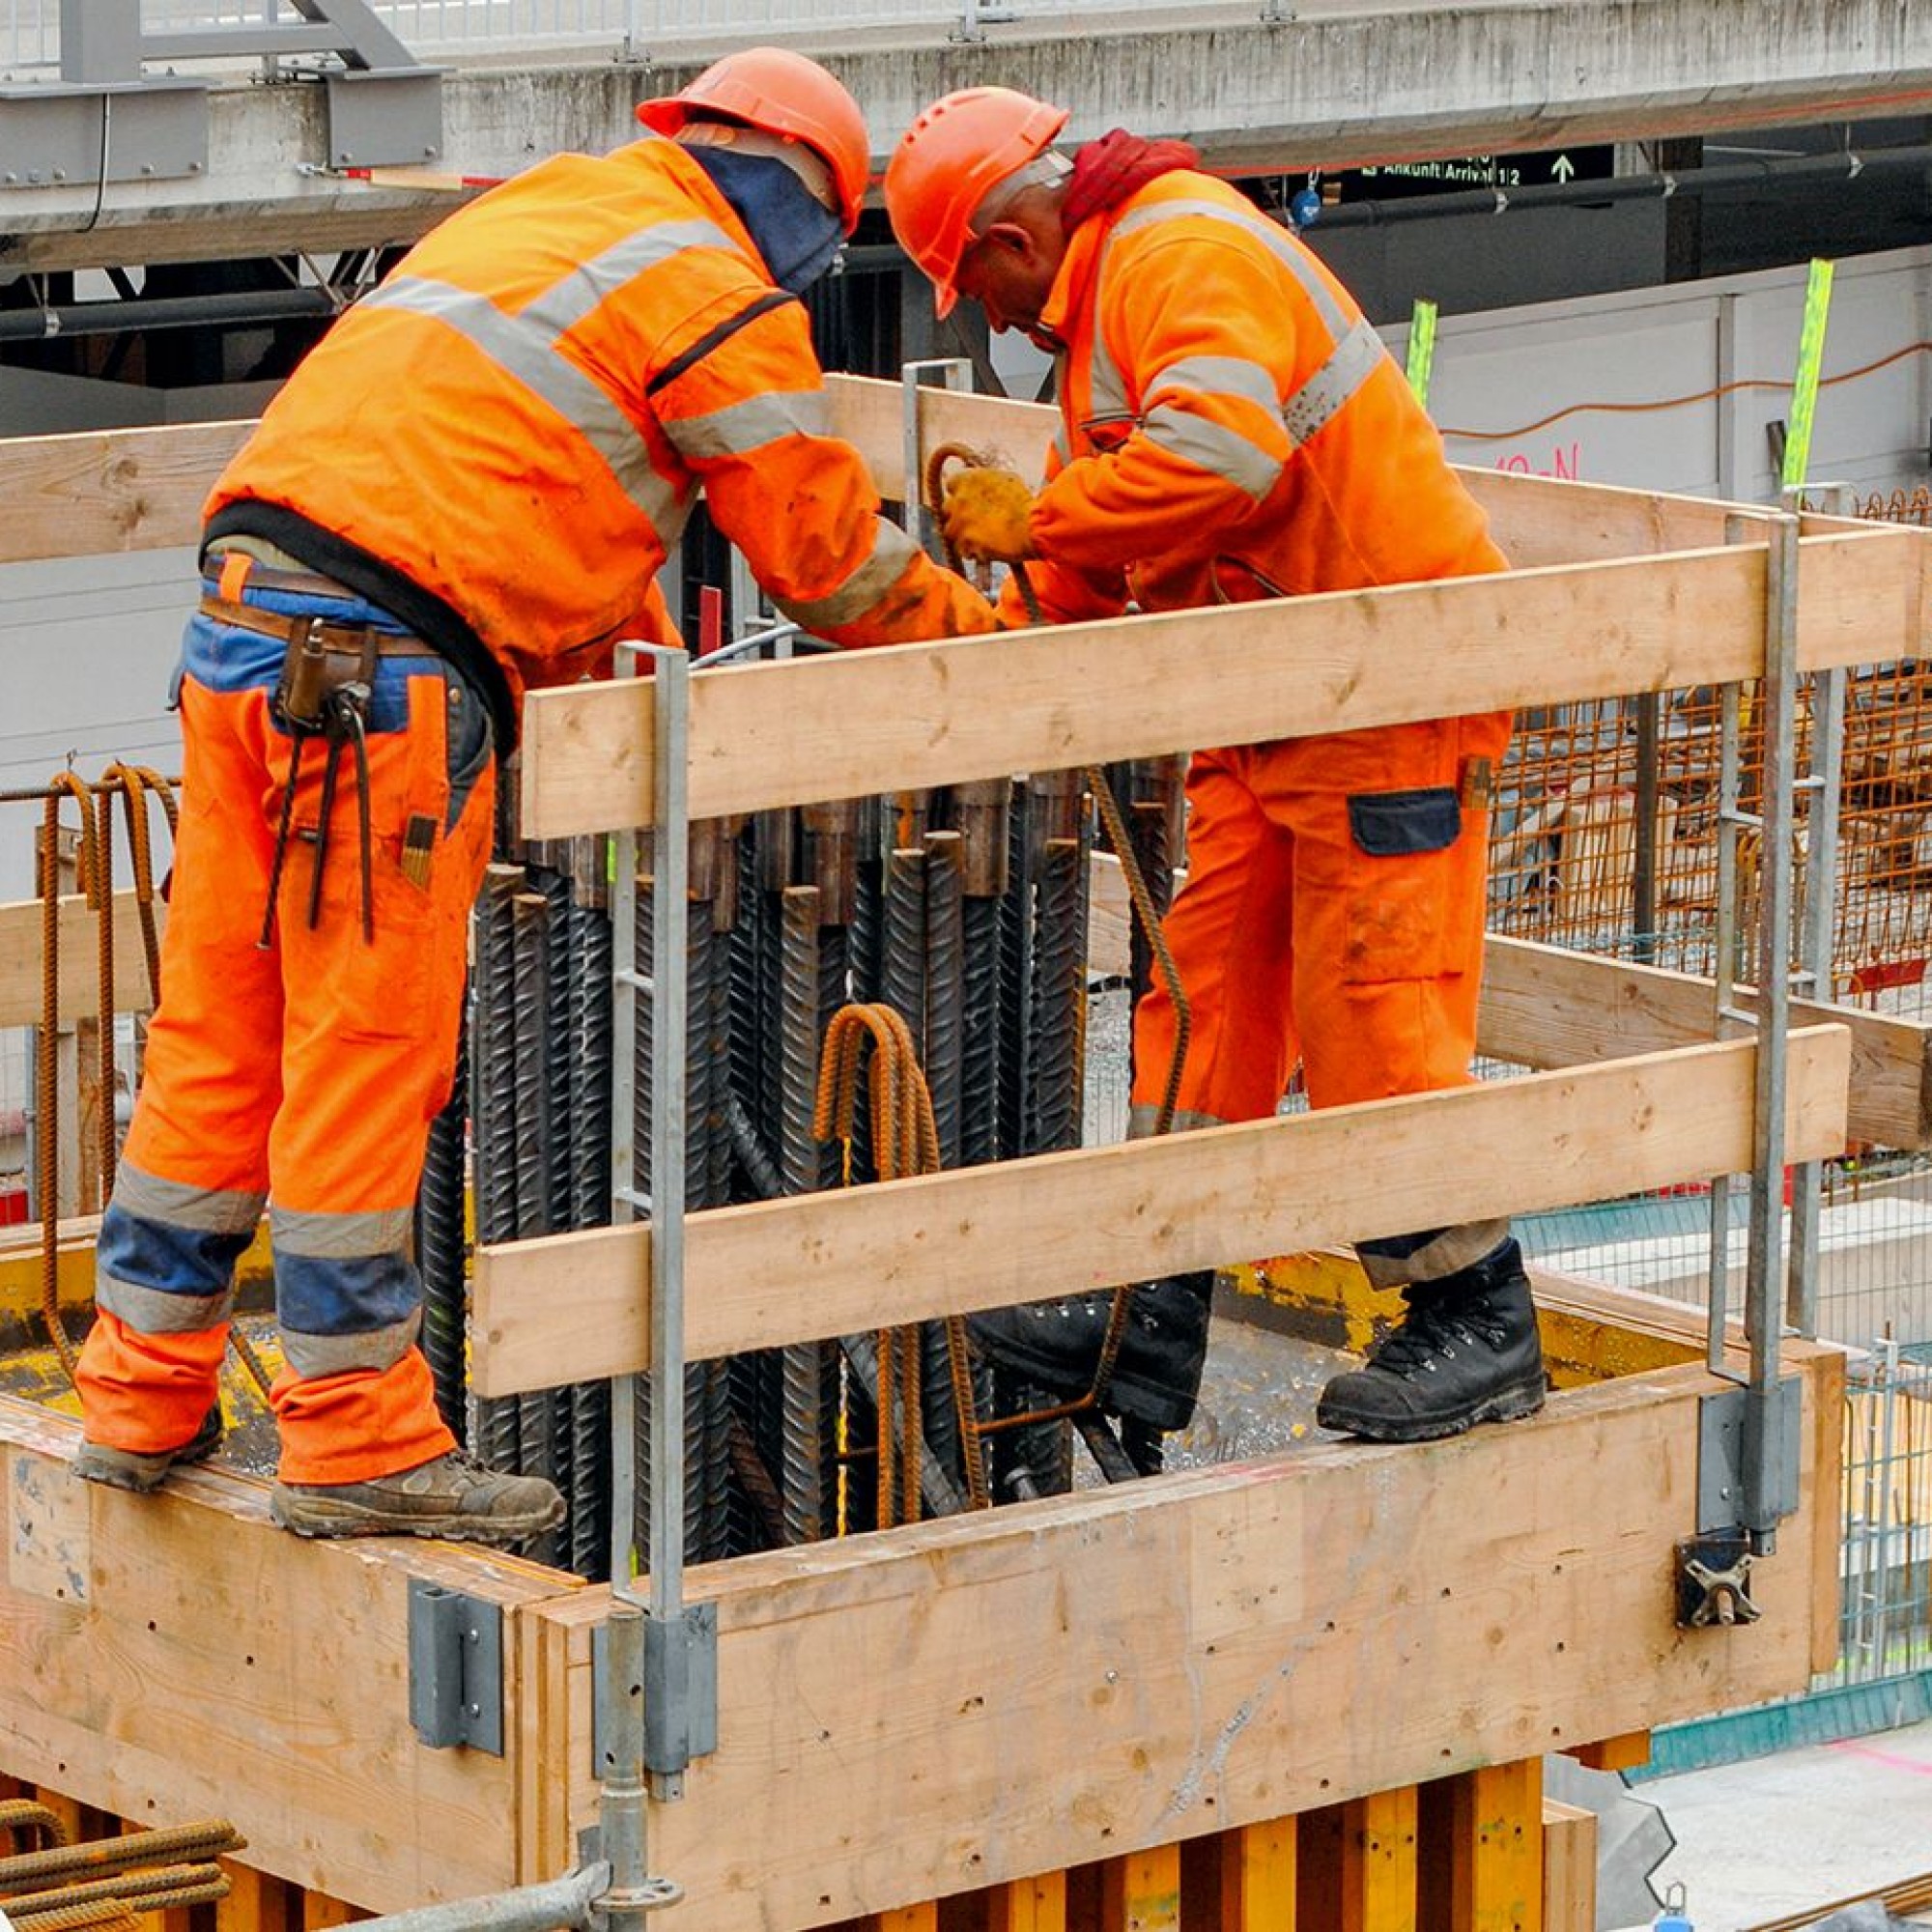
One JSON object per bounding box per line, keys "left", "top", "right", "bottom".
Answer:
{"left": 885, "top": 87, "right": 1544, "bottom": 1441}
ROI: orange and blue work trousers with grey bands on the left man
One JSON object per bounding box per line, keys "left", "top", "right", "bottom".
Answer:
{"left": 79, "top": 585, "right": 495, "bottom": 1484}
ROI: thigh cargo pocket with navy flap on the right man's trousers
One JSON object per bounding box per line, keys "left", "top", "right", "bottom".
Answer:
{"left": 1343, "top": 784, "right": 1463, "bottom": 985}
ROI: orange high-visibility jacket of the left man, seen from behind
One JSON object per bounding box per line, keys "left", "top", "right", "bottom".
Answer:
{"left": 207, "top": 135, "right": 993, "bottom": 730}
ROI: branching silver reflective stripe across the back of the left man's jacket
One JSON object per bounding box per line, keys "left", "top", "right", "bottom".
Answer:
{"left": 359, "top": 222, "right": 744, "bottom": 549}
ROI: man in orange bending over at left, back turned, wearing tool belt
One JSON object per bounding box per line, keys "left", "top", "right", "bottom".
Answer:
{"left": 75, "top": 48, "right": 995, "bottom": 1542}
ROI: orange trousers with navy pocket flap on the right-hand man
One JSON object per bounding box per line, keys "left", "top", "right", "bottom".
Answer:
{"left": 1132, "top": 713, "right": 1509, "bottom": 1130}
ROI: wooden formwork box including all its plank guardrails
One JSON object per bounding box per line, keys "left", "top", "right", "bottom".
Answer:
{"left": 0, "top": 392, "right": 1926, "bottom": 1932}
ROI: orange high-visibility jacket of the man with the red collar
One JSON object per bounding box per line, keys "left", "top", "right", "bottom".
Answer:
{"left": 1009, "top": 172, "right": 1505, "bottom": 620}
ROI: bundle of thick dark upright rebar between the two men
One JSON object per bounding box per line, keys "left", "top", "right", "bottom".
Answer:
{"left": 446, "top": 746, "right": 1179, "bottom": 1578}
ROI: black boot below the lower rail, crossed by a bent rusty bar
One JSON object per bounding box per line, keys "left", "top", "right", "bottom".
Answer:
{"left": 966, "top": 1267, "right": 1213, "bottom": 1430}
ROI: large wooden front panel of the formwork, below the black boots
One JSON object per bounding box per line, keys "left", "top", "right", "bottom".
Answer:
{"left": 564, "top": 1343, "right": 1837, "bottom": 1932}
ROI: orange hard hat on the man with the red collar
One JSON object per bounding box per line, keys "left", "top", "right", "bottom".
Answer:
{"left": 885, "top": 87, "right": 1066, "bottom": 315}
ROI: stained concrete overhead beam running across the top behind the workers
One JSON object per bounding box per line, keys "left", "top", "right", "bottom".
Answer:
{"left": 0, "top": 0, "right": 1932, "bottom": 278}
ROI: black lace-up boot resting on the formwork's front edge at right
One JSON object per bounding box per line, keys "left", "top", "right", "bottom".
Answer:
{"left": 1316, "top": 1240, "right": 1544, "bottom": 1443}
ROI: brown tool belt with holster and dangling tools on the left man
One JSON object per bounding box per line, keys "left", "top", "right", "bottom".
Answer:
{"left": 201, "top": 587, "right": 439, "bottom": 949}
